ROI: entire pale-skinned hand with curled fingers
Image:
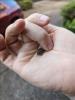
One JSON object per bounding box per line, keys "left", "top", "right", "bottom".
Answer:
{"left": 0, "top": 14, "right": 75, "bottom": 94}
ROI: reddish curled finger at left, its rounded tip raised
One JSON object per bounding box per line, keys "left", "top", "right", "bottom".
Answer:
{"left": 5, "top": 19, "right": 25, "bottom": 54}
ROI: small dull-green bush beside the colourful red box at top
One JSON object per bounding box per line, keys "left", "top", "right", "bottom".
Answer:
{"left": 16, "top": 0, "right": 32, "bottom": 10}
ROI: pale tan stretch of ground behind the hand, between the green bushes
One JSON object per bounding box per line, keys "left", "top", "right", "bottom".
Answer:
{"left": 24, "top": 0, "right": 67, "bottom": 17}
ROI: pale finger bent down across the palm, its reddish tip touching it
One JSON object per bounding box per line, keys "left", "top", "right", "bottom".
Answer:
{"left": 25, "top": 21, "right": 53, "bottom": 50}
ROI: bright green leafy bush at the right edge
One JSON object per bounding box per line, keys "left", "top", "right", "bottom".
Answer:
{"left": 61, "top": 0, "right": 75, "bottom": 32}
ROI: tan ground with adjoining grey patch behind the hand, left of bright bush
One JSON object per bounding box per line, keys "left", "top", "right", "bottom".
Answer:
{"left": 24, "top": 0, "right": 67, "bottom": 26}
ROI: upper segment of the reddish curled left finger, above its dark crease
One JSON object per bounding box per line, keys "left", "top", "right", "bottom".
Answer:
{"left": 5, "top": 19, "right": 25, "bottom": 44}
